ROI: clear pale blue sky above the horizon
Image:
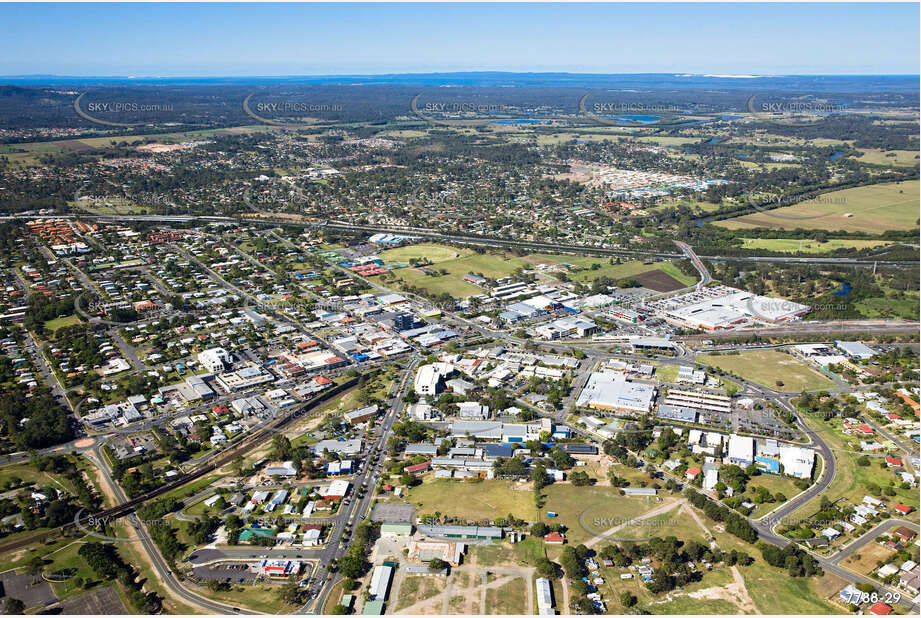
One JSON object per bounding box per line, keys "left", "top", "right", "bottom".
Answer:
{"left": 0, "top": 2, "right": 921, "bottom": 77}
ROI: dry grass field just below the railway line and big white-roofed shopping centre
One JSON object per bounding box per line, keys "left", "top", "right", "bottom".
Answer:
{"left": 696, "top": 350, "right": 835, "bottom": 393}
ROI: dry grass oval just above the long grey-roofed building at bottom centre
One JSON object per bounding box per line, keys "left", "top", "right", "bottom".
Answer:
{"left": 406, "top": 479, "right": 537, "bottom": 521}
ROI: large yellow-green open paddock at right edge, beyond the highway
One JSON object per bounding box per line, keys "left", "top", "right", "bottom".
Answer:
{"left": 714, "top": 180, "right": 921, "bottom": 234}
